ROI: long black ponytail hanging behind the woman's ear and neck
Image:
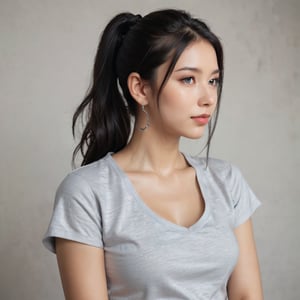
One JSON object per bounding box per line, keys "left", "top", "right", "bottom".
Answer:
{"left": 72, "top": 13, "right": 141, "bottom": 166}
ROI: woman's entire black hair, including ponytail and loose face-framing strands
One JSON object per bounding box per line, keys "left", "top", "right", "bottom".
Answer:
{"left": 72, "top": 9, "right": 224, "bottom": 165}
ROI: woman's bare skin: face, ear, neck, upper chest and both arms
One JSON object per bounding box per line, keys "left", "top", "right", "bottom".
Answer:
{"left": 56, "top": 40, "right": 263, "bottom": 300}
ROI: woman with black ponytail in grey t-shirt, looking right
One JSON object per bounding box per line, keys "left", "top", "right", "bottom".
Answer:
{"left": 44, "top": 10, "right": 262, "bottom": 300}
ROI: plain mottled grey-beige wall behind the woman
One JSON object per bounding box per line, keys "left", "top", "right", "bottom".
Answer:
{"left": 0, "top": 0, "right": 300, "bottom": 300}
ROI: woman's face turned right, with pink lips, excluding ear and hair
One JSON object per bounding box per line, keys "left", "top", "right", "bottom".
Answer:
{"left": 149, "top": 40, "right": 219, "bottom": 139}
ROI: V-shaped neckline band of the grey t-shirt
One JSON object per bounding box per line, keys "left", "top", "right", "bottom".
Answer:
{"left": 107, "top": 152, "right": 210, "bottom": 232}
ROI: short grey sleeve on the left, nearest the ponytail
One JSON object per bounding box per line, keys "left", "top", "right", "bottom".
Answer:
{"left": 43, "top": 173, "right": 103, "bottom": 253}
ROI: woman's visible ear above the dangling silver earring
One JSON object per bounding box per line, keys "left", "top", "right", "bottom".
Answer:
{"left": 127, "top": 72, "right": 150, "bottom": 105}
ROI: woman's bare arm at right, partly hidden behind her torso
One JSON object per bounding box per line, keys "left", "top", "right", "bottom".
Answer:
{"left": 228, "top": 219, "right": 263, "bottom": 300}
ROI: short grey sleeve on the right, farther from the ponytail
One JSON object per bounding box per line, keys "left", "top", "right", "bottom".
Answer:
{"left": 230, "top": 166, "right": 261, "bottom": 227}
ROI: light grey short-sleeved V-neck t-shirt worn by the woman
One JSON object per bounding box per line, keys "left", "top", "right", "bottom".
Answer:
{"left": 43, "top": 153, "right": 260, "bottom": 300}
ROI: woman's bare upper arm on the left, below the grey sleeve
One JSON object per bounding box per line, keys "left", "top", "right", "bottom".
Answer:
{"left": 56, "top": 238, "right": 108, "bottom": 300}
